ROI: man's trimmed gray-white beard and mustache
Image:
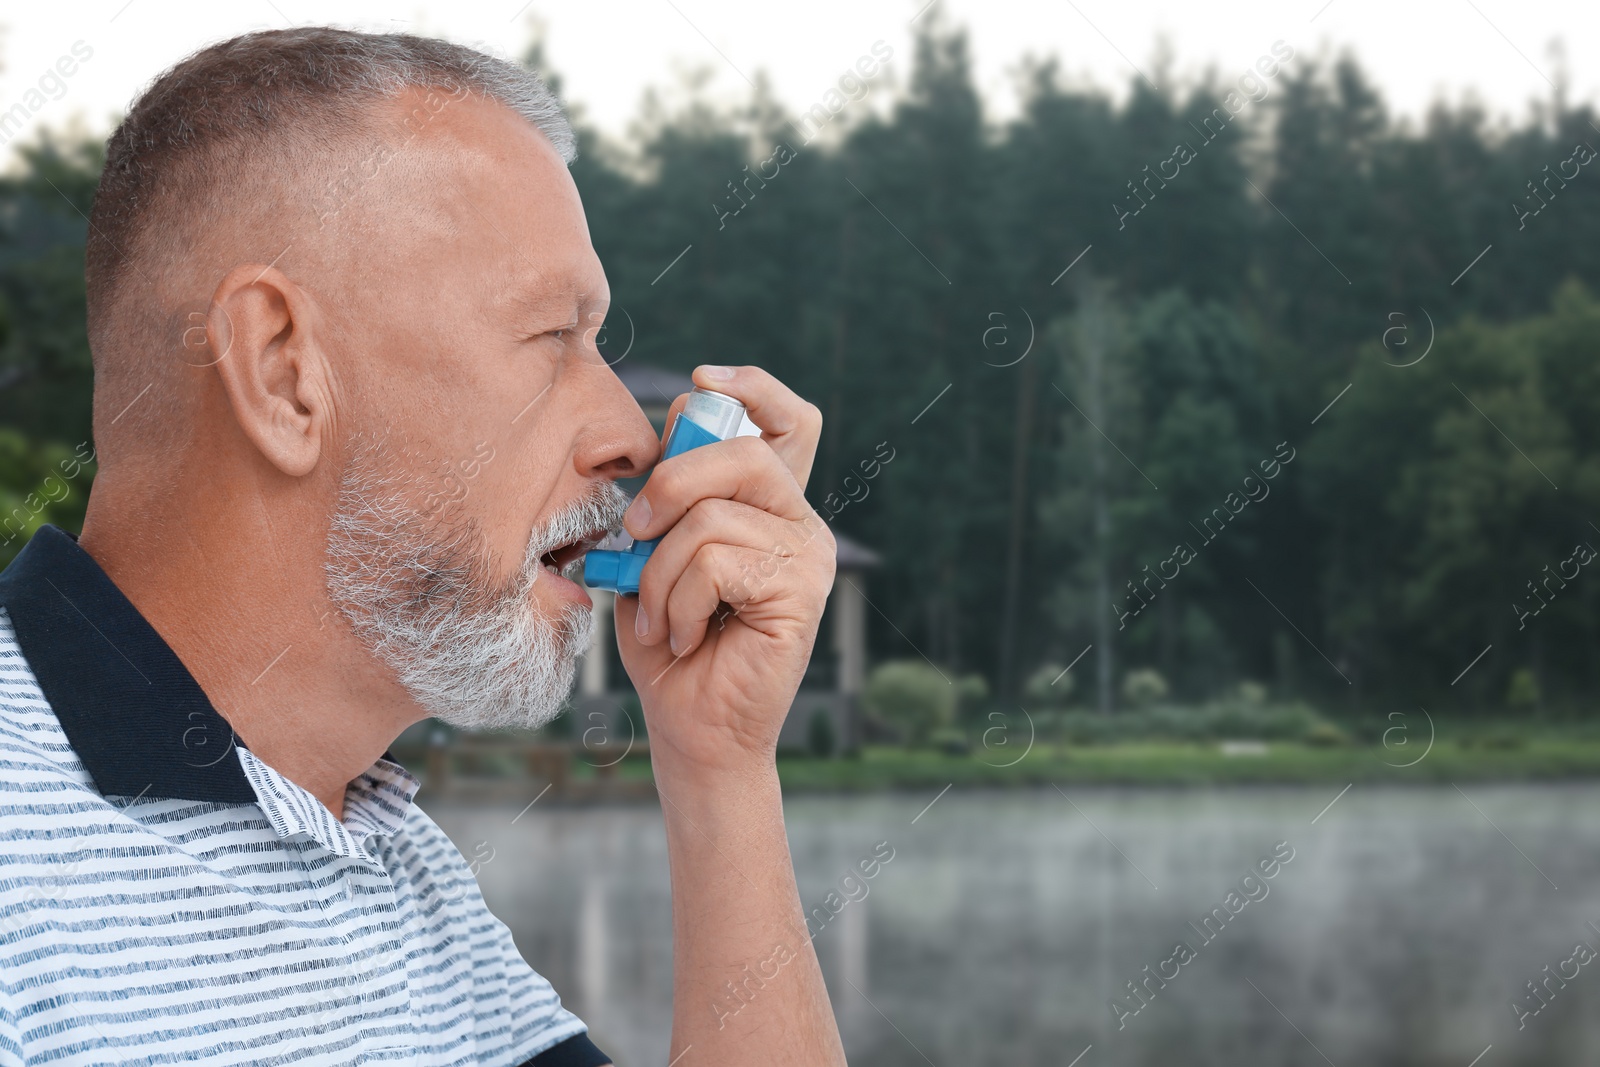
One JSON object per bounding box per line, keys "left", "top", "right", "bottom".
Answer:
{"left": 325, "top": 445, "right": 627, "bottom": 729}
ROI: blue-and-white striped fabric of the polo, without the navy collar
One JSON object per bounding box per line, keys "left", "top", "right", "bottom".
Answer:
{"left": 0, "top": 611, "right": 592, "bottom": 1067}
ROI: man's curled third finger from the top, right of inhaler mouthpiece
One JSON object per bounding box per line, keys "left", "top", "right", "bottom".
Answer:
{"left": 634, "top": 499, "right": 796, "bottom": 653}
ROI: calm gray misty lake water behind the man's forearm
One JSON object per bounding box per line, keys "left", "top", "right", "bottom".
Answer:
{"left": 422, "top": 784, "right": 1600, "bottom": 1067}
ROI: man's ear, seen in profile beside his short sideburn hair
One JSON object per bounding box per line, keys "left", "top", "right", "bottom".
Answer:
{"left": 206, "top": 264, "right": 333, "bottom": 478}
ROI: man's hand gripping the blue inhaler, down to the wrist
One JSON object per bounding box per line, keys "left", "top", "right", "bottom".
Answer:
{"left": 616, "top": 366, "right": 835, "bottom": 773}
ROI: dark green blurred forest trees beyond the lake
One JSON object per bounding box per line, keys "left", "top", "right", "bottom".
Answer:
{"left": 0, "top": 11, "right": 1600, "bottom": 713}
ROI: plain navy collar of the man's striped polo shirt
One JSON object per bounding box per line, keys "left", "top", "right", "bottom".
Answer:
{"left": 0, "top": 526, "right": 256, "bottom": 803}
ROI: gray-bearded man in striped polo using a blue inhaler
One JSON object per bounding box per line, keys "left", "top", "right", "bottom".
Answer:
{"left": 0, "top": 29, "right": 843, "bottom": 1067}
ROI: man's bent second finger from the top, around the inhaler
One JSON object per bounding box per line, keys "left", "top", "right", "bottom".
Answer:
{"left": 622, "top": 437, "right": 811, "bottom": 541}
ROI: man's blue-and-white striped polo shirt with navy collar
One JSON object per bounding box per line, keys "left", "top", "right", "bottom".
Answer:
{"left": 0, "top": 526, "right": 608, "bottom": 1067}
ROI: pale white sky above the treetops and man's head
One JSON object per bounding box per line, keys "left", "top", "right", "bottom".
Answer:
{"left": 0, "top": 0, "right": 1600, "bottom": 163}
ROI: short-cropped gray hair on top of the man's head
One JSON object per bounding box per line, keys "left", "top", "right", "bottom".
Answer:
{"left": 83, "top": 27, "right": 578, "bottom": 457}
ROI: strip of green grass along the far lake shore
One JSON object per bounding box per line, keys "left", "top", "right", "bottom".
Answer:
{"left": 778, "top": 737, "right": 1600, "bottom": 790}
